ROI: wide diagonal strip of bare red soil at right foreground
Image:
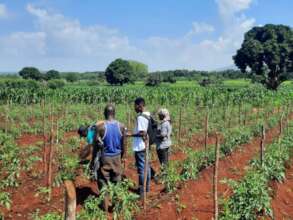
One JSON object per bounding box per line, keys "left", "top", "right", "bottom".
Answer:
{"left": 137, "top": 122, "right": 279, "bottom": 220}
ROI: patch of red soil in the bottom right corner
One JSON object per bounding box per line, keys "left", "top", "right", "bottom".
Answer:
{"left": 272, "top": 160, "right": 293, "bottom": 220}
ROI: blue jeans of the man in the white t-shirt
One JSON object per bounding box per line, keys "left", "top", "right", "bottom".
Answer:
{"left": 135, "top": 151, "right": 151, "bottom": 195}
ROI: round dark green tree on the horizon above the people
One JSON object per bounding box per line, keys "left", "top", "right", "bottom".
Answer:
{"left": 105, "top": 59, "right": 135, "bottom": 85}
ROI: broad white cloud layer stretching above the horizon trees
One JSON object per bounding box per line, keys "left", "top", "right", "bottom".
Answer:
{"left": 0, "top": 0, "right": 256, "bottom": 71}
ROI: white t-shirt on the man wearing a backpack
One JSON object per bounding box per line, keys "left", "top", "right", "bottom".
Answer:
{"left": 132, "top": 112, "right": 151, "bottom": 151}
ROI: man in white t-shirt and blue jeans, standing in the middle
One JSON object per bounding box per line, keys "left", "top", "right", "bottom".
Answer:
{"left": 128, "top": 97, "right": 151, "bottom": 198}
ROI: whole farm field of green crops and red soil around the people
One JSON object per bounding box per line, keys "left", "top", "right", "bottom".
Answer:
{"left": 0, "top": 83, "right": 293, "bottom": 220}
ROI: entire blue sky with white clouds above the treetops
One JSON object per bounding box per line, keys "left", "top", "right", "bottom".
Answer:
{"left": 0, "top": 0, "right": 293, "bottom": 72}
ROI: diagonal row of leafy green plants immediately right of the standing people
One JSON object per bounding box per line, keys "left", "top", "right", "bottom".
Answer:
{"left": 162, "top": 110, "right": 280, "bottom": 192}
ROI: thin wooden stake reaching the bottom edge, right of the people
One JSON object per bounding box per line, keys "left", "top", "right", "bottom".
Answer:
{"left": 214, "top": 133, "right": 220, "bottom": 220}
